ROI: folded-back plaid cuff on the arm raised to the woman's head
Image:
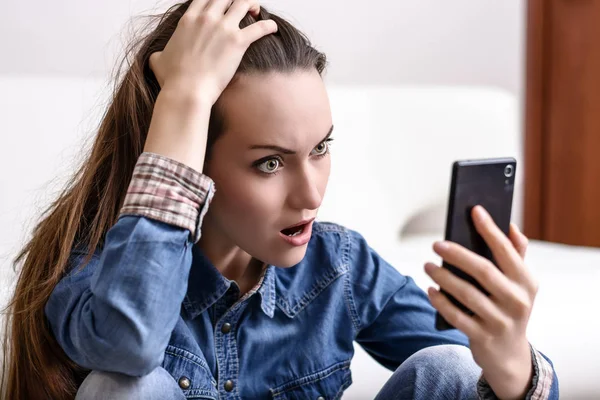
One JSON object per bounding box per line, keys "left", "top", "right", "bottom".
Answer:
{"left": 119, "top": 152, "right": 215, "bottom": 243}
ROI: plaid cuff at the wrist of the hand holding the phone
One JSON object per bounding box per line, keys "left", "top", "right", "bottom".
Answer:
{"left": 477, "top": 344, "right": 554, "bottom": 400}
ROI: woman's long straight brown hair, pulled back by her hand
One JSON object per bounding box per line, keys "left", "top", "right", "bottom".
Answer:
{"left": 0, "top": 1, "right": 326, "bottom": 400}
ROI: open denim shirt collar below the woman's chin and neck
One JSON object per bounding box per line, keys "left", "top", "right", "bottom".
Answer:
{"left": 183, "top": 242, "right": 276, "bottom": 319}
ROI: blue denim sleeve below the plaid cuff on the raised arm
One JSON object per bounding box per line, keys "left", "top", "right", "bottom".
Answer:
{"left": 81, "top": 216, "right": 192, "bottom": 375}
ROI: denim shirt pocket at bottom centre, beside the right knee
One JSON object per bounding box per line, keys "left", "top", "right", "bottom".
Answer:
{"left": 271, "top": 360, "right": 352, "bottom": 400}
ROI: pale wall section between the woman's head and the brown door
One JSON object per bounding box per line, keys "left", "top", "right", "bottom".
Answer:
{"left": 266, "top": 0, "right": 524, "bottom": 93}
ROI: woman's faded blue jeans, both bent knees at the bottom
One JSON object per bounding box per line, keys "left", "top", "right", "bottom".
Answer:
{"left": 75, "top": 345, "right": 481, "bottom": 400}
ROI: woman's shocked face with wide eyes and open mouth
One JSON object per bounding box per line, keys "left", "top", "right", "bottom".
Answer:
{"left": 204, "top": 70, "right": 333, "bottom": 267}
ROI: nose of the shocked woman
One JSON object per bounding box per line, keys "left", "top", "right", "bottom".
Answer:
{"left": 289, "top": 165, "right": 327, "bottom": 210}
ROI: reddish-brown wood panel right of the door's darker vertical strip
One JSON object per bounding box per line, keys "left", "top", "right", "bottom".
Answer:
{"left": 541, "top": 0, "right": 600, "bottom": 246}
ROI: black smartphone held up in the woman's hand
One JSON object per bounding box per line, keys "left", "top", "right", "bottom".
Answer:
{"left": 435, "top": 157, "right": 517, "bottom": 330}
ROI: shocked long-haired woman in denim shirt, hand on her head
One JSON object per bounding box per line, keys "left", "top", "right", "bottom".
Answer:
{"left": 4, "top": 0, "right": 558, "bottom": 399}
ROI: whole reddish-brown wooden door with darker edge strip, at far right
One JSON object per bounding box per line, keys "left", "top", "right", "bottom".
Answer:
{"left": 524, "top": 0, "right": 600, "bottom": 247}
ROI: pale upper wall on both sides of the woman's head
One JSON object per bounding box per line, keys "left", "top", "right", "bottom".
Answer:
{"left": 0, "top": 0, "right": 525, "bottom": 95}
